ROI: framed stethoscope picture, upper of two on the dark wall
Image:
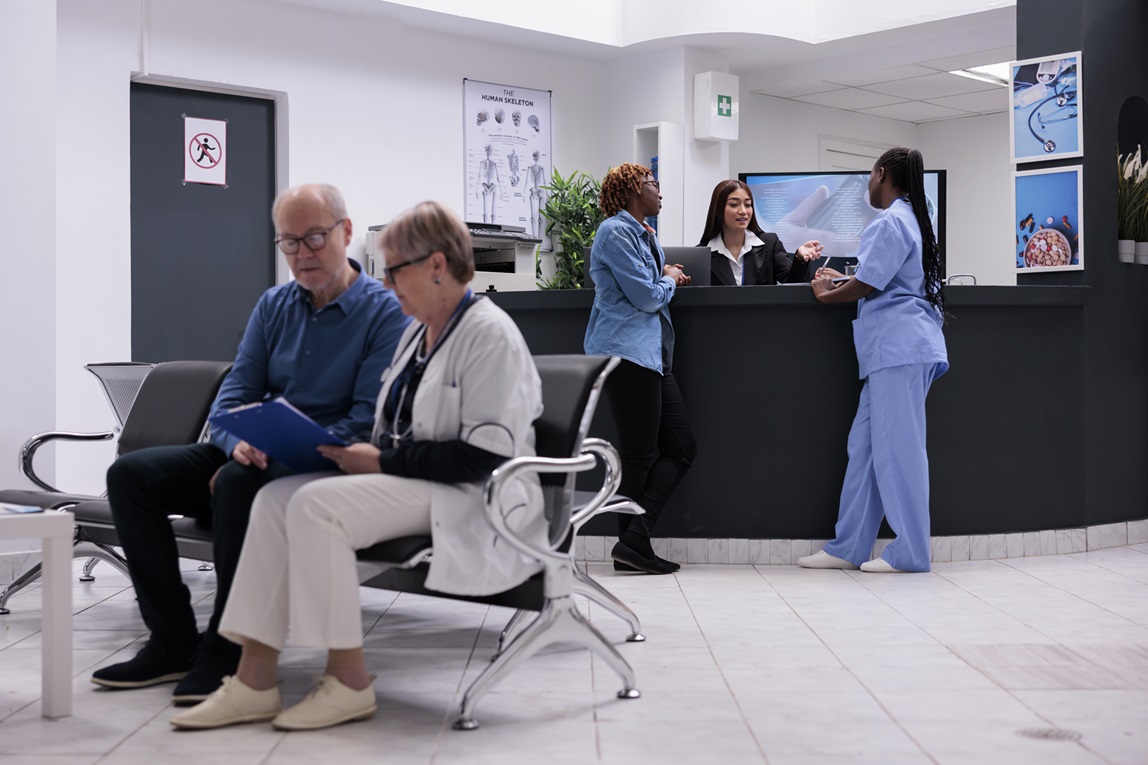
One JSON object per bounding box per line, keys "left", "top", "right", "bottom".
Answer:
{"left": 1009, "top": 51, "right": 1084, "bottom": 163}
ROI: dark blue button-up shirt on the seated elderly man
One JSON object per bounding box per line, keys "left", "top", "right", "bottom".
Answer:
{"left": 211, "top": 261, "right": 410, "bottom": 455}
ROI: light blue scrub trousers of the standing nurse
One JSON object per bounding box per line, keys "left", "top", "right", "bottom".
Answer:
{"left": 825, "top": 364, "right": 947, "bottom": 571}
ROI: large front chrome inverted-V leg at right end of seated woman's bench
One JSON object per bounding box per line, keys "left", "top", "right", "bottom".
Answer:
{"left": 453, "top": 596, "right": 642, "bottom": 731}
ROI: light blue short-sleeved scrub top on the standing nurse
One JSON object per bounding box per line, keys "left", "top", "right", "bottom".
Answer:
{"left": 853, "top": 199, "right": 948, "bottom": 379}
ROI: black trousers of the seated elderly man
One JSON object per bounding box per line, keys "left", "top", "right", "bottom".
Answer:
{"left": 108, "top": 443, "right": 292, "bottom": 655}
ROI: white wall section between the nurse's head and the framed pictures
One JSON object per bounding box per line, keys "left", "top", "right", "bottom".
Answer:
{"left": 917, "top": 114, "right": 1016, "bottom": 285}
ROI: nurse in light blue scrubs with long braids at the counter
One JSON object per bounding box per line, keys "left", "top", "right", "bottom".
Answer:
{"left": 798, "top": 148, "right": 948, "bottom": 573}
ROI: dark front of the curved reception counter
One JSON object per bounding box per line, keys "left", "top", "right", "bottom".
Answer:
{"left": 488, "top": 285, "right": 1089, "bottom": 539}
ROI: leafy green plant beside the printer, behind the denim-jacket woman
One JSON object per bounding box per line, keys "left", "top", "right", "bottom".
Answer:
{"left": 538, "top": 169, "right": 605, "bottom": 289}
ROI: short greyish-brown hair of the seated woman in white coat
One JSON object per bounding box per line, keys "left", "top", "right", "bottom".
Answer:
{"left": 379, "top": 201, "right": 474, "bottom": 284}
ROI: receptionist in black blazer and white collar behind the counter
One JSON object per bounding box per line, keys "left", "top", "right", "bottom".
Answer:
{"left": 698, "top": 180, "right": 822, "bottom": 286}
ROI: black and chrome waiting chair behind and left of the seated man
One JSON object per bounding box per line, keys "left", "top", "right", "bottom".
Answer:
{"left": 0, "top": 361, "right": 231, "bottom": 615}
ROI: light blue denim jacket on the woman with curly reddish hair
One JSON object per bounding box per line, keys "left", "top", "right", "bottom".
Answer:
{"left": 583, "top": 210, "right": 676, "bottom": 374}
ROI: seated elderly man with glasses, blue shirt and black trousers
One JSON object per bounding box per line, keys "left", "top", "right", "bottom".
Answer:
{"left": 92, "top": 184, "right": 409, "bottom": 703}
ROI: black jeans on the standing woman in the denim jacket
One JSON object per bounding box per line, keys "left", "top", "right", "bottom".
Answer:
{"left": 606, "top": 360, "right": 698, "bottom": 536}
